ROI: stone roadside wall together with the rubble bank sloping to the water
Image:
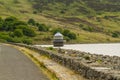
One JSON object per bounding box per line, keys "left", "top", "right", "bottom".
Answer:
{"left": 11, "top": 44, "right": 120, "bottom": 80}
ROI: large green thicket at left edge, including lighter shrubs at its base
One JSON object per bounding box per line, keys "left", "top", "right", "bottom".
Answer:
{"left": 0, "top": 17, "right": 36, "bottom": 44}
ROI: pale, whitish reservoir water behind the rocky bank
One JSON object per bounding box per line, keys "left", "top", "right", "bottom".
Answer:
{"left": 36, "top": 43, "right": 120, "bottom": 57}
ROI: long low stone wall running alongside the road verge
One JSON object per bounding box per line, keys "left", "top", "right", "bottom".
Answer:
{"left": 11, "top": 44, "right": 120, "bottom": 80}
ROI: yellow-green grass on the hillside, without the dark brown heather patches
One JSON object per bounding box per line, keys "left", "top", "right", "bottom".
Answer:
{"left": 0, "top": 0, "right": 120, "bottom": 44}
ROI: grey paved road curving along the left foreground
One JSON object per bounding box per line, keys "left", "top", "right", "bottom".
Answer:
{"left": 0, "top": 45, "right": 48, "bottom": 80}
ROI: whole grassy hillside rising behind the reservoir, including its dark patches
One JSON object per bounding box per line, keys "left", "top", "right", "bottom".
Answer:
{"left": 0, "top": 0, "right": 120, "bottom": 43}
